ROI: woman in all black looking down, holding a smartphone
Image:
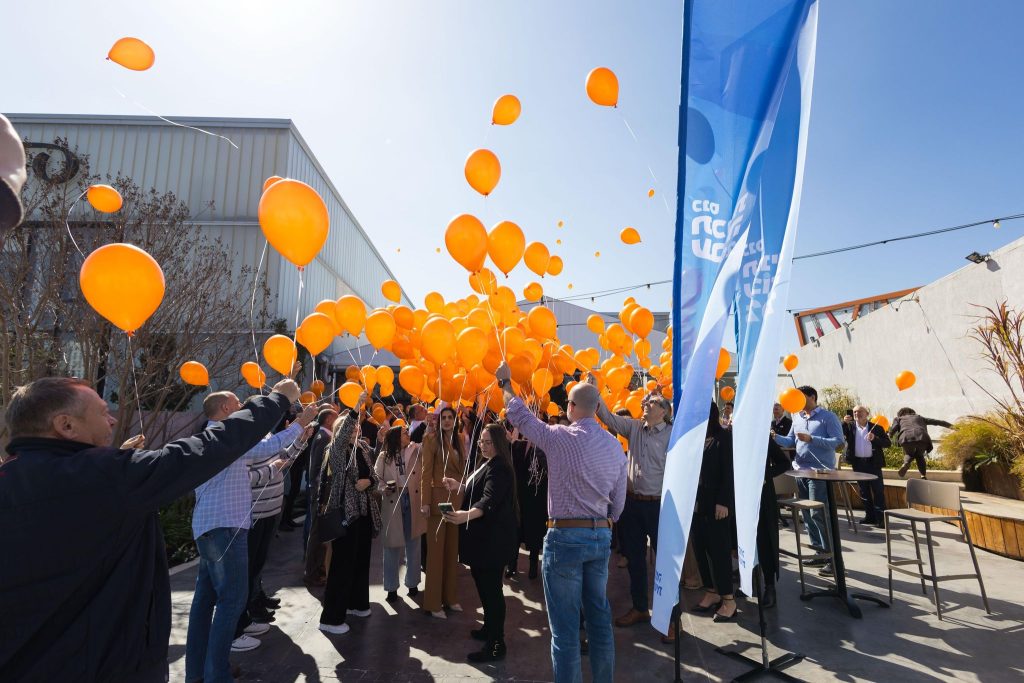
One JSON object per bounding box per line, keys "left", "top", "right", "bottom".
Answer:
{"left": 443, "top": 424, "right": 519, "bottom": 661}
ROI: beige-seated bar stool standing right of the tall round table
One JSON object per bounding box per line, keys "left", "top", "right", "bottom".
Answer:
{"left": 885, "top": 479, "right": 992, "bottom": 621}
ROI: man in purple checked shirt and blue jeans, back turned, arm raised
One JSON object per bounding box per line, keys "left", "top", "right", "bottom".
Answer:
{"left": 495, "top": 362, "right": 626, "bottom": 683}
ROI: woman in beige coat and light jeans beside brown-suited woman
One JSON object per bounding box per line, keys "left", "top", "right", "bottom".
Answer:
{"left": 374, "top": 427, "right": 427, "bottom": 602}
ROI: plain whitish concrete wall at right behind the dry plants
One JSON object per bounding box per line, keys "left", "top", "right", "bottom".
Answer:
{"left": 778, "top": 239, "right": 1024, "bottom": 422}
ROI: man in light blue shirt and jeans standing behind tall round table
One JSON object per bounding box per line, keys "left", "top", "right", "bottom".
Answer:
{"left": 775, "top": 386, "right": 846, "bottom": 577}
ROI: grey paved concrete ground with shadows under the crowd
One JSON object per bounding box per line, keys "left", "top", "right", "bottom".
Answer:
{"left": 170, "top": 516, "right": 1024, "bottom": 683}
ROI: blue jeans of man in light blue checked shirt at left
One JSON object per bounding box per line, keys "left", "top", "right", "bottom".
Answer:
{"left": 185, "top": 527, "right": 249, "bottom": 683}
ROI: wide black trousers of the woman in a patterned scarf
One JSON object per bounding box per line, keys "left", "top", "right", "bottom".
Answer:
{"left": 321, "top": 517, "right": 373, "bottom": 626}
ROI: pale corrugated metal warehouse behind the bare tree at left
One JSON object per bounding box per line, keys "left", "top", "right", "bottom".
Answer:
{"left": 7, "top": 114, "right": 410, "bottom": 360}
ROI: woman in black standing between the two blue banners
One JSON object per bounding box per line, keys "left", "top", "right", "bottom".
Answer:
{"left": 691, "top": 403, "right": 736, "bottom": 622}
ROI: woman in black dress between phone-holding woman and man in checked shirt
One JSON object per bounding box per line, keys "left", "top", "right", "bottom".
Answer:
{"left": 505, "top": 438, "right": 548, "bottom": 579}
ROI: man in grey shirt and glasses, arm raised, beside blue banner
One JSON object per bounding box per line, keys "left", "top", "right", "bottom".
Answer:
{"left": 587, "top": 385, "right": 672, "bottom": 627}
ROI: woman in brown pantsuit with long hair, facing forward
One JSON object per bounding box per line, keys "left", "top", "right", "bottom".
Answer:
{"left": 420, "top": 407, "right": 466, "bottom": 618}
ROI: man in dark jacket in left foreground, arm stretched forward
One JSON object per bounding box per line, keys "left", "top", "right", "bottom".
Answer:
{"left": 0, "top": 378, "right": 299, "bottom": 683}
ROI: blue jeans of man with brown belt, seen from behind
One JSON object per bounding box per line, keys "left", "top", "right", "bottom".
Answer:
{"left": 543, "top": 528, "right": 615, "bottom": 683}
